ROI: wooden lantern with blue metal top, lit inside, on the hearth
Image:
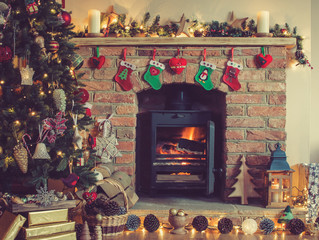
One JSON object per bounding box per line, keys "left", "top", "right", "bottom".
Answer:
{"left": 266, "top": 143, "right": 294, "bottom": 208}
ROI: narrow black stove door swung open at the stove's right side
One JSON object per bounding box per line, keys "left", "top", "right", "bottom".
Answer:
{"left": 206, "top": 121, "right": 215, "bottom": 195}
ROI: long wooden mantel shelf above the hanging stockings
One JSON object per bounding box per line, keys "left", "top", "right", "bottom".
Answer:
{"left": 71, "top": 37, "right": 296, "bottom": 48}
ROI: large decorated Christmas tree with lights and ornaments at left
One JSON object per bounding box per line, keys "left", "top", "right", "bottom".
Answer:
{"left": 0, "top": 0, "right": 96, "bottom": 191}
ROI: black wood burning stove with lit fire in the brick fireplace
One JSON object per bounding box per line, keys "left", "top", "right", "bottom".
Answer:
{"left": 136, "top": 109, "right": 215, "bottom": 194}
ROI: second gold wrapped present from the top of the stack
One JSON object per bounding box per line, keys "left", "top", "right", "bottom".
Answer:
{"left": 23, "top": 222, "right": 75, "bottom": 238}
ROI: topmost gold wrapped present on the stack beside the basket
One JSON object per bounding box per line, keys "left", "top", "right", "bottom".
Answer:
{"left": 28, "top": 209, "right": 68, "bottom": 226}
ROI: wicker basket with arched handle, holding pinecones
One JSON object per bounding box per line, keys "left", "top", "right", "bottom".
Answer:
{"left": 85, "top": 178, "right": 128, "bottom": 236}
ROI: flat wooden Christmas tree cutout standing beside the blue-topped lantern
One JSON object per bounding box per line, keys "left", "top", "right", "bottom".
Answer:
{"left": 228, "top": 156, "right": 259, "bottom": 204}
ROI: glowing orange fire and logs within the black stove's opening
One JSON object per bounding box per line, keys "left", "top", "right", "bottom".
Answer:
{"left": 154, "top": 126, "right": 207, "bottom": 182}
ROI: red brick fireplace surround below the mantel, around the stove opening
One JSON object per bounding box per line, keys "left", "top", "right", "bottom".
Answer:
{"left": 75, "top": 39, "right": 288, "bottom": 202}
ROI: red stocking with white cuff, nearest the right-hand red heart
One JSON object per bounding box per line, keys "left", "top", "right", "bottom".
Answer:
{"left": 223, "top": 48, "right": 243, "bottom": 91}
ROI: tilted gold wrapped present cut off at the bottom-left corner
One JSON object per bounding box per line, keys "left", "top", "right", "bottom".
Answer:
{"left": 0, "top": 211, "right": 26, "bottom": 240}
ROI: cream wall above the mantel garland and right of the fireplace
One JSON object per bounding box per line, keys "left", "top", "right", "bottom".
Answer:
{"left": 66, "top": 0, "right": 319, "bottom": 165}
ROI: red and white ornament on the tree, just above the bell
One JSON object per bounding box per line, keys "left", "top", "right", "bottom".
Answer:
{"left": 43, "top": 112, "right": 68, "bottom": 143}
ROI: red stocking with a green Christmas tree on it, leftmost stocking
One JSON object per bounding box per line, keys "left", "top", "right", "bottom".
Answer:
{"left": 115, "top": 48, "right": 136, "bottom": 91}
